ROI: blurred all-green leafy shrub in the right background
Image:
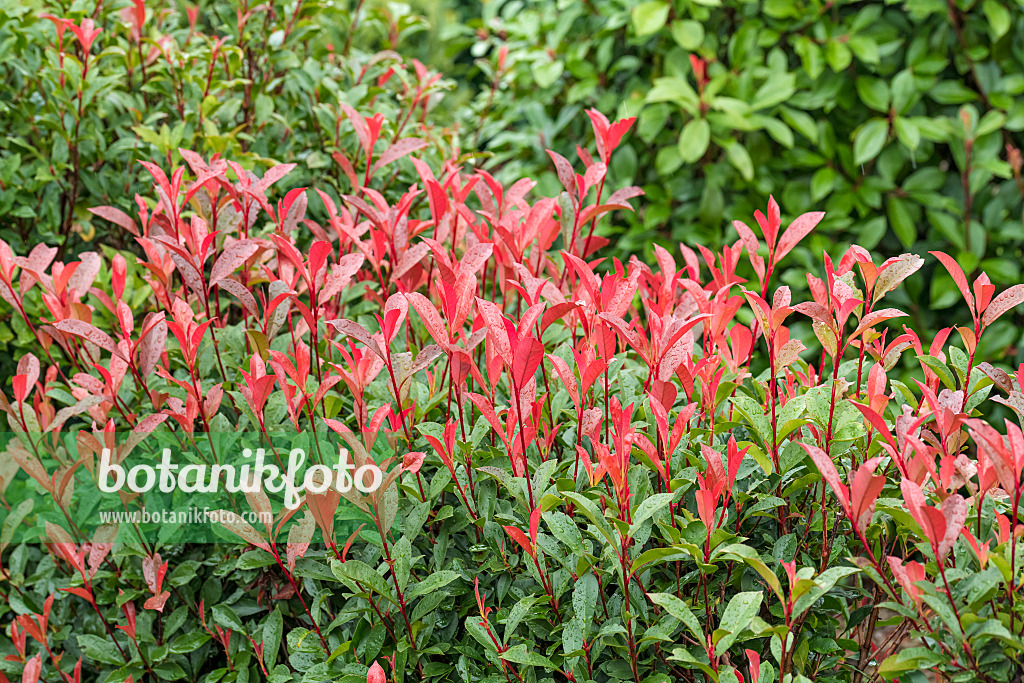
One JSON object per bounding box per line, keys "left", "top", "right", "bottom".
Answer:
{"left": 457, "top": 0, "right": 1024, "bottom": 342}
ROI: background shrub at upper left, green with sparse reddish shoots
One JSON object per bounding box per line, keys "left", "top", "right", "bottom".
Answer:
{"left": 0, "top": 0, "right": 452, "bottom": 253}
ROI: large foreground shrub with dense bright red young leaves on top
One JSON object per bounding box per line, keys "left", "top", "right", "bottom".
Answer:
{"left": 0, "top": 100, "right": 1024, "bottom": 683}
